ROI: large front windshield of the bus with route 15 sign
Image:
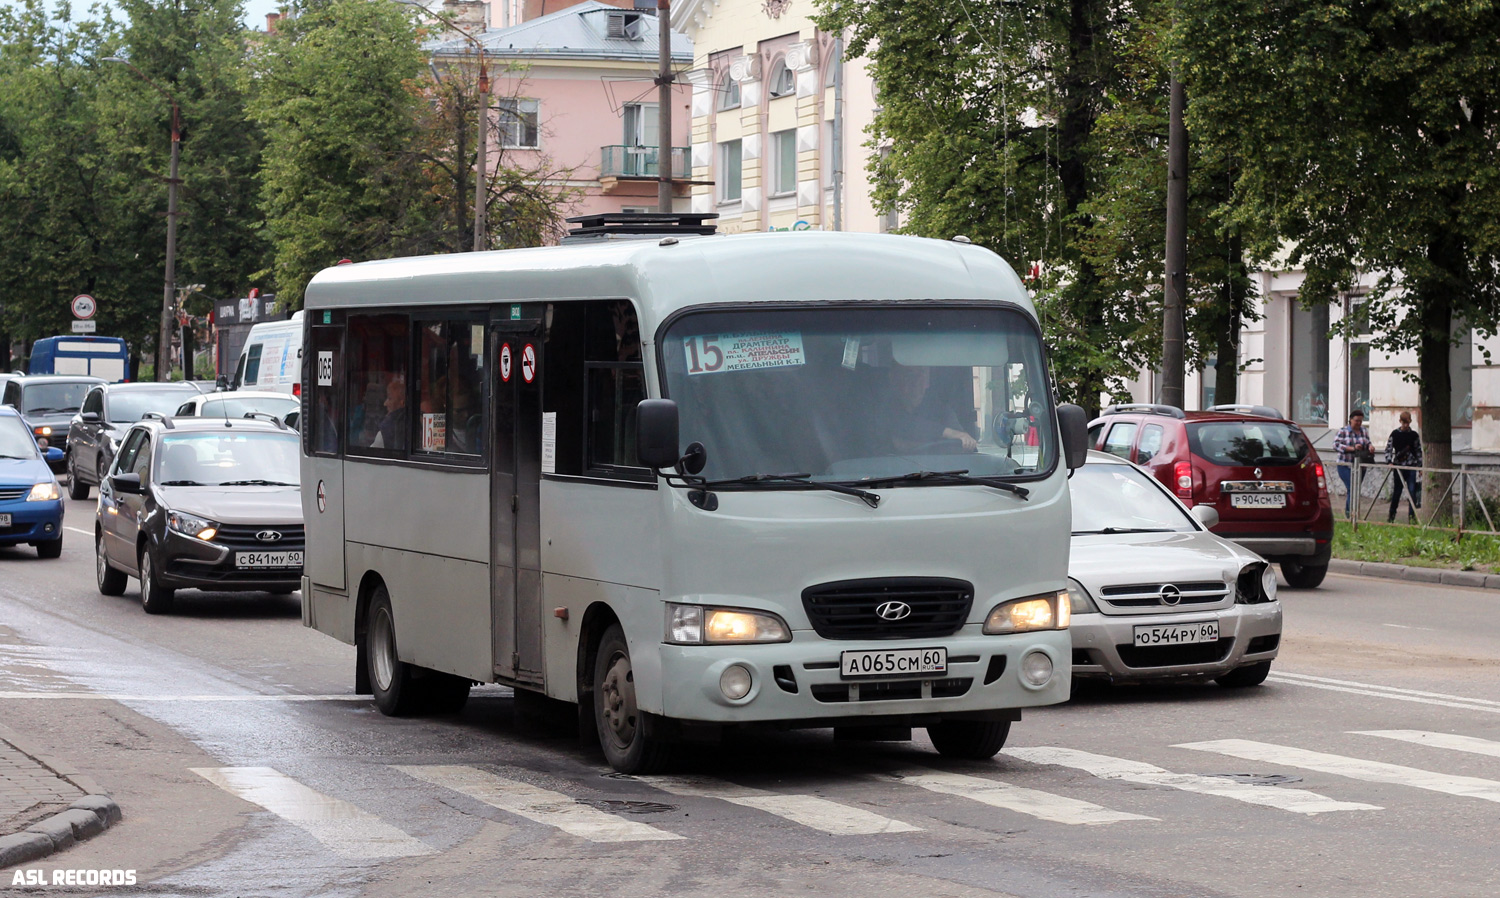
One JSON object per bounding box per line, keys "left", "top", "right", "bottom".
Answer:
{"left": 660, "top": 304, "right": 1058, "bottom": 484}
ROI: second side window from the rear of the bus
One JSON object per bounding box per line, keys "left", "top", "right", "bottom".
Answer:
{"left": 345, "top": 315, "right": 411, "bottom": 456}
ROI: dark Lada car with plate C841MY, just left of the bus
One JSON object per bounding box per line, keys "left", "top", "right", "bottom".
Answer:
{"left": 95, "top": 418, "right": 303, "bottom": 615}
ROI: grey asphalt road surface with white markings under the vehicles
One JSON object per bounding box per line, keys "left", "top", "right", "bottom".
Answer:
{"left": 0, "top": 502, "right": 1500, "bottom": 898}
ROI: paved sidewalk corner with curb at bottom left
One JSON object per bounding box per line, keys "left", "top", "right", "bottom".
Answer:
{"left": 0, "top": 726, "right": 120, "bottom": 868}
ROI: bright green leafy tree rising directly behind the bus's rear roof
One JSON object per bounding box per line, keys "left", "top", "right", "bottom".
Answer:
{"left": 251, "top": 0, "right": 455, "bottom": 307}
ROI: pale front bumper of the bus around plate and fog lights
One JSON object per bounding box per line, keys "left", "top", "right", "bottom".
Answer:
{"left": 660, "top": 630, "right": 1073, "bottom": 727}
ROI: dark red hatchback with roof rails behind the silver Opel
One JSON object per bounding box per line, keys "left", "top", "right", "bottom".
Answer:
{"left": 1089, "top": 405, "right": 1334, "bottom": 589}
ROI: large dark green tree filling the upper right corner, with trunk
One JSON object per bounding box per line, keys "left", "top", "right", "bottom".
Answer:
{"left": 1175, "top": 0, "right": 1500, "bottom": 485}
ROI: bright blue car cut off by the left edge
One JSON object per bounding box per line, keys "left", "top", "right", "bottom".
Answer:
{"left": 0, "top": 408, "right": 63, "bottom": 558}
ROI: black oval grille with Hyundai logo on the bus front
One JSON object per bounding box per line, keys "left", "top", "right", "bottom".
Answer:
{"left": 803, "top": 577, "right": 974, "bottom": 639}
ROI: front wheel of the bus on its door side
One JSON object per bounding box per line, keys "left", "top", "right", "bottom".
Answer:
{"left": 594, "top": 624, "right": 672, "bottom": 774}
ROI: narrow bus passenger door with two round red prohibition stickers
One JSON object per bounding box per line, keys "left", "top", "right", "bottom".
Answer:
{"left": 491, "top": 319, "right": 543, "bottom": 685}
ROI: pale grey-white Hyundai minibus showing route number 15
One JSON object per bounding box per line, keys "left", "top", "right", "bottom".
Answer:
{"left": 302, "top": 232, "right": 1086, "bottom": 772}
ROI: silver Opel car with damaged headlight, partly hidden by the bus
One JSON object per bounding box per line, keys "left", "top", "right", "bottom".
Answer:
{"left": 1068, "top": 453, "right": 1281, "bottom": 687}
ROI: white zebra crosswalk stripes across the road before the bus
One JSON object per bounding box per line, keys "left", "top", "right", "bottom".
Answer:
{"left": 192, "top": 730, "right": 1500, "bottom": 861}
